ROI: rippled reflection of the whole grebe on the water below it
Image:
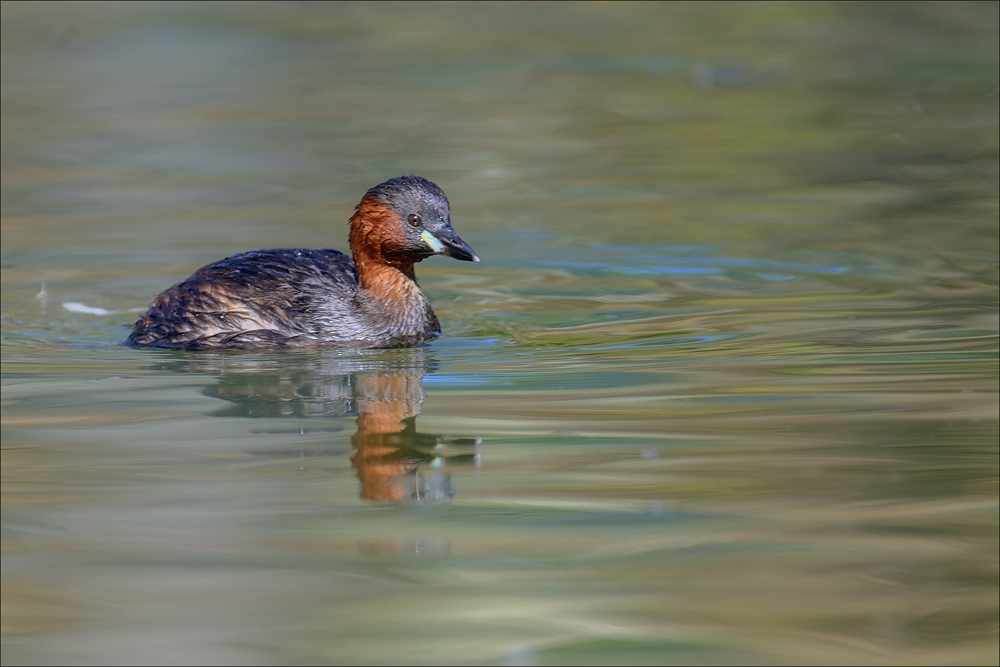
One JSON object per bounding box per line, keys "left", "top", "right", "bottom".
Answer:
{"left": 153, "top": 349, "right": 480, "bottom": 503}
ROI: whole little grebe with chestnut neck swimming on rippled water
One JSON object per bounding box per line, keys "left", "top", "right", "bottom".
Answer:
{"left": 125, "top": 176, "right": 479, "bottom": 350}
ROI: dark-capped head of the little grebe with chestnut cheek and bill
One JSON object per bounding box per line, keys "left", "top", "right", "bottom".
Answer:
{"left": 350, "top": 176, "right": 479, "bottom": 263}
